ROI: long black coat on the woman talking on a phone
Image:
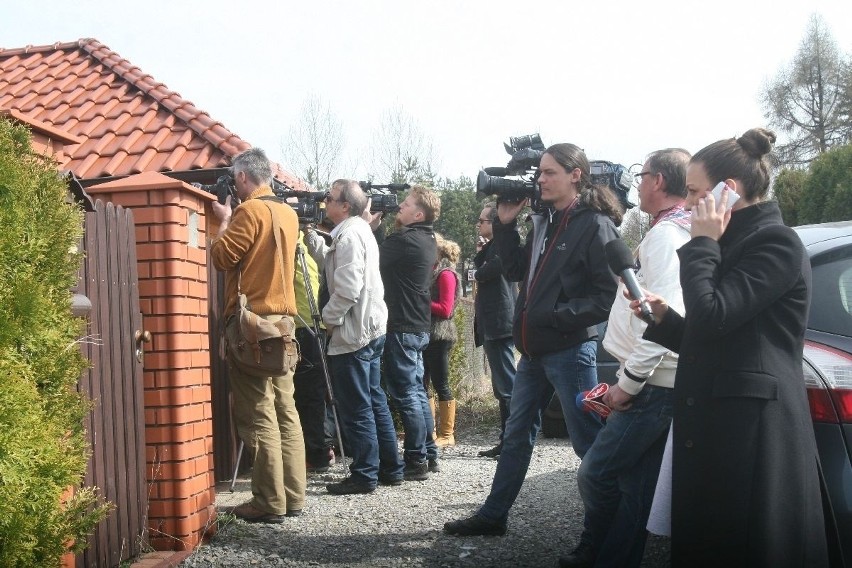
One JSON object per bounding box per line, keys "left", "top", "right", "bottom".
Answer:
{"left": 645, "top": 203, "right": 828, "bottom": 567}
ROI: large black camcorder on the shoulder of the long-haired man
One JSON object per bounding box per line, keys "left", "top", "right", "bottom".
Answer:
{"left": 476, "top": 134, "right": 635, "bottom": 211}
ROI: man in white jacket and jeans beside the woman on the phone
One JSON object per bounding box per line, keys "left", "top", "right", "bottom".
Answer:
{"left": 560, "top": 148, "right": 690, "bottom": 567}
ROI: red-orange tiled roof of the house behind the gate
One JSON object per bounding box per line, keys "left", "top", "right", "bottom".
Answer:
{"left": 0, "top": 39, "right": 303, "bottom": 186}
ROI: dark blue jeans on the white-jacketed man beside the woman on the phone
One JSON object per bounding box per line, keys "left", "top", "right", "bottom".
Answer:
{"left": 577, "top": 385, "right": 674, "bottom": 566}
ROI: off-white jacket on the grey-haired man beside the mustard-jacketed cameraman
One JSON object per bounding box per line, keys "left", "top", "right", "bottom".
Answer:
{"left": 308, "top": 217, "right": 388, "bottom": 355}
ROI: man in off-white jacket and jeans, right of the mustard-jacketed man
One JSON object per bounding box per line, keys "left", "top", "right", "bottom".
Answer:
{"left": 308, "top": 180, "right": 403, "bottom": 495}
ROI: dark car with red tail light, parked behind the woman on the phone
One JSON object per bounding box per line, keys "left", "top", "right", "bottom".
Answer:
{"left": 542, "top": 221, "right": 852, "bottom": 566}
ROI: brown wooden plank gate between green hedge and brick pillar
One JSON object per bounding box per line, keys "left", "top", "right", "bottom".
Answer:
{"left": 76, "top": 201, "right": 148, "bottom": 567}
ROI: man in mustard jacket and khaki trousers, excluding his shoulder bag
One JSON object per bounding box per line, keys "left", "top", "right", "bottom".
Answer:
{"left": 210, "top": 148, "right": 307, "bottom": 523}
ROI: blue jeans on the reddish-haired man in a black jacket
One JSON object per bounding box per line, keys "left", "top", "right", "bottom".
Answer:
{"left": 385, "top": 332, "right": 438, "bottom": 463}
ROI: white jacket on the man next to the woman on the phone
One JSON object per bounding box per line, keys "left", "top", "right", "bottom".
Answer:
{"left": 603, "top": 219, "right": 690, "bottom": 395}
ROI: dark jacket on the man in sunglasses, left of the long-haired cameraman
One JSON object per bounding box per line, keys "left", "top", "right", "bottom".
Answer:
{"left": 473, "top": 241, "right": 517, "bottom": 347}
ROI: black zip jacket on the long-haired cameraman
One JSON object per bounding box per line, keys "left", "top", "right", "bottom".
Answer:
{"left": 494, "top": 203, "right": 618, "bottom": 356}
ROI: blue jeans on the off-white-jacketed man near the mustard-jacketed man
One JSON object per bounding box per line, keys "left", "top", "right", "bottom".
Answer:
{"left": 328, "top": 336, "right": 403, "bottom": 487}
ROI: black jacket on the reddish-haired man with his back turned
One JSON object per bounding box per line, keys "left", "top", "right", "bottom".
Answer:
{"left": 379, "top": 223, "right": 438, "bottom": 333}
